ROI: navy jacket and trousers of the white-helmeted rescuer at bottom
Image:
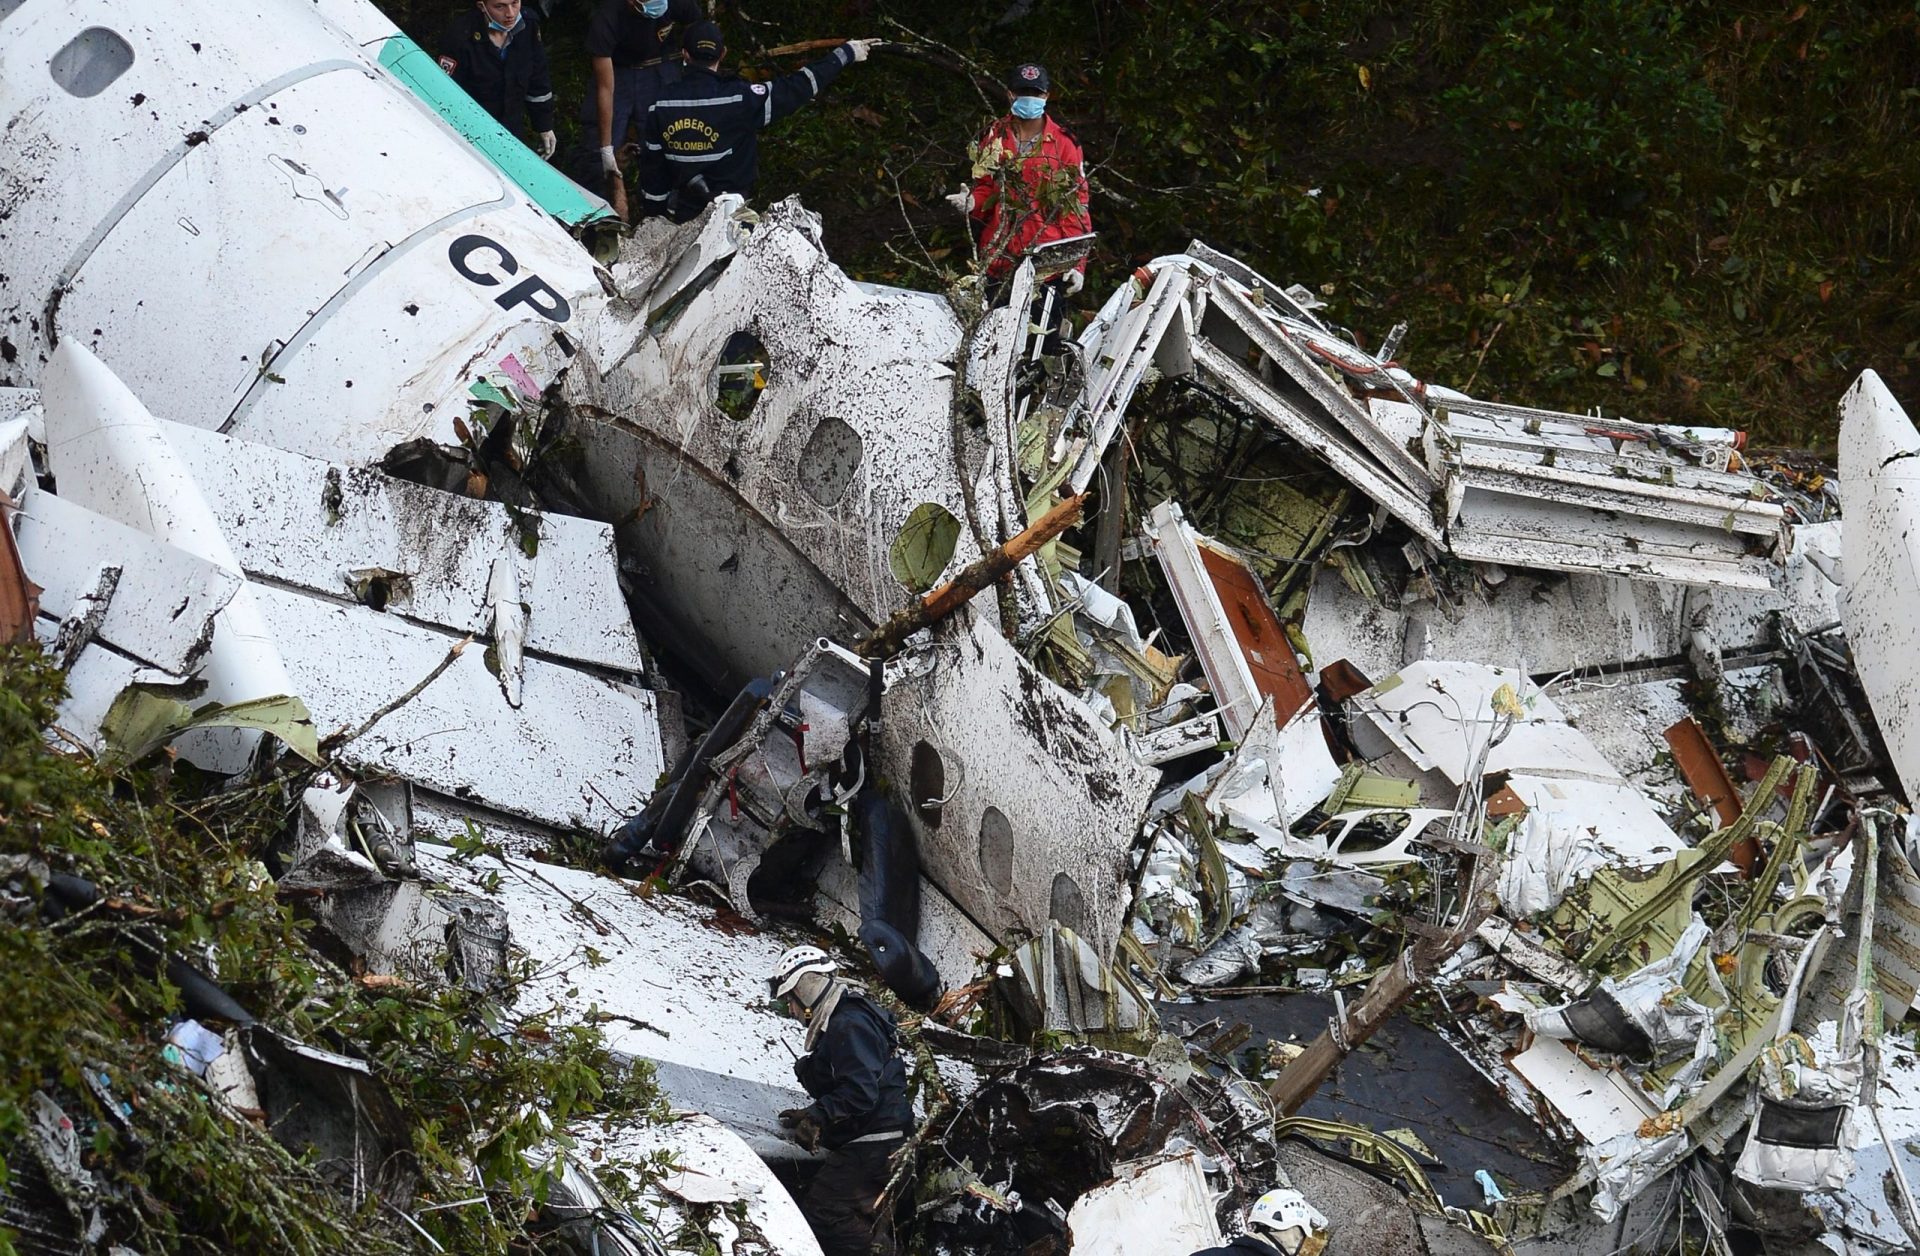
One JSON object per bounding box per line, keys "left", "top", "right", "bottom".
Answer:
{"left": 793, "top": 991, "right": 914, "bottom": 1256}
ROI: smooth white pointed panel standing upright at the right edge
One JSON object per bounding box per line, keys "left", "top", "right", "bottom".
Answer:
{"left": 1839, "top": 371, "right": 1920, "bottom": 801}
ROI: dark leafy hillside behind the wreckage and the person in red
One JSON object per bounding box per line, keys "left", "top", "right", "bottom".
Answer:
{"left": 388, "top": 0, "right": 1920, "bottom": 447}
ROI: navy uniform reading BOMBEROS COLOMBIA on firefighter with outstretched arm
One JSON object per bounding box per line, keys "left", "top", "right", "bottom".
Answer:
{"left": 639, "top": 44, "right": 852, "bottom": 213}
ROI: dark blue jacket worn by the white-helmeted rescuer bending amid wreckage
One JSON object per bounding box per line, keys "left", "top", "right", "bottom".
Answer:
{"left": 793, "top": 989, "right": 914, "bottom": 1150}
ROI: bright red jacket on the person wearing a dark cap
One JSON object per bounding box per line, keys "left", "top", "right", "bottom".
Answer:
{"left": 972, "top": 115, "right": 1092, "bottom": 278}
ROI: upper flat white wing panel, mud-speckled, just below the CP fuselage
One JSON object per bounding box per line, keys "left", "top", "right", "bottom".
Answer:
{"left": 161, "top": 423, "right": 643, "bottom": 672}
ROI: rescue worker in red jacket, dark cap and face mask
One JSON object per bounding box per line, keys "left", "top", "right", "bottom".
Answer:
{"left": 947, "top": 61, "right": 1092, "bottom": 296}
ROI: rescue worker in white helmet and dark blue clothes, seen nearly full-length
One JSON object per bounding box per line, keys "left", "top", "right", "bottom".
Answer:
{"left": 766, "top": 947, "right": 914, "bottom": 1256}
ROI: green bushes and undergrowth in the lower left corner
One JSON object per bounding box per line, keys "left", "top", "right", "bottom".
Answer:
{"left": 0, "top": 645, "right": 657, "bottom": 1252}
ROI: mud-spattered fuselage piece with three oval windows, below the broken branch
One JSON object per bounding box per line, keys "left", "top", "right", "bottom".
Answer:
{"left": 877, "top": 607, "right": 1158, "bottom": 956}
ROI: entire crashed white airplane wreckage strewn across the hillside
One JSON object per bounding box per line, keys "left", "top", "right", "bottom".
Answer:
{"left": 0, "top": 0, "right": 1920, "bottom": 1254}
